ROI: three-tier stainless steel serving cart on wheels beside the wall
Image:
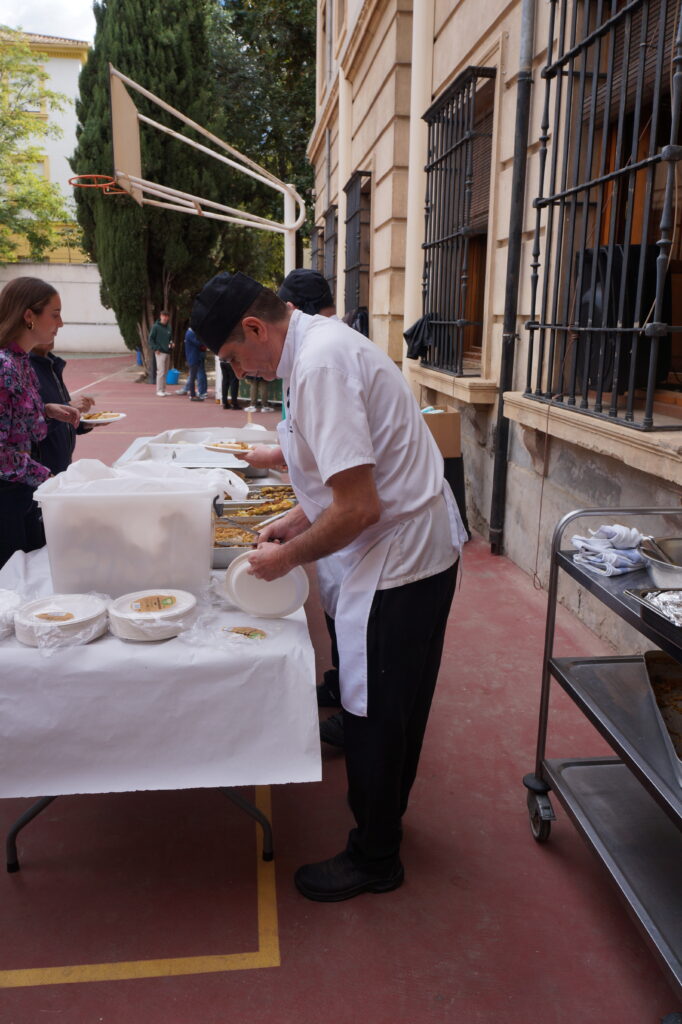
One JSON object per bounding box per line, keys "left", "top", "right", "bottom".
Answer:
{"left": 523, "top": 507, "right": 682, "bottom": 1011}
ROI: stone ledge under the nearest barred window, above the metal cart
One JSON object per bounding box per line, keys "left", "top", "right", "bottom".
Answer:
{"left": 504, "top": 391, "right": 682, "bottom": 486}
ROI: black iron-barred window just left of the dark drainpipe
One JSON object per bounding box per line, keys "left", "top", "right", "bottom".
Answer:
{"left": 422, "top": 67, "right": 496, "bottom": 377}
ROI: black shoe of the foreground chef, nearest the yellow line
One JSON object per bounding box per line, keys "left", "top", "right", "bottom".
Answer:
{"left": 294, "top": 850, "right": 404, "bottom": 903}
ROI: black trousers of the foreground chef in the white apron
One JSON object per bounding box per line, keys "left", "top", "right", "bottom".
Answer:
{"left": 333, "top": 564, "right": 457, "bottom": 869}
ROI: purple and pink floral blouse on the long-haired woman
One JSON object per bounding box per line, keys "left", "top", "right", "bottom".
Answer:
{"left": 0, "top": 342, "right": 50, "bottom": 487}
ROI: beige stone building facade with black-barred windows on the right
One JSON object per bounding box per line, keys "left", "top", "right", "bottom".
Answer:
{"left": 308, "top": 0, "right": 682, "bottom": 630}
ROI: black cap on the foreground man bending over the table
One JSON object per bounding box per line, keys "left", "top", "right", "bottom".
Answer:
{"left": 189, "top": 270, "right": 263, "bottom": 355}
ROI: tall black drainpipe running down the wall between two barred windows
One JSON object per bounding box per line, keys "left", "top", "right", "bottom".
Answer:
{"left": 489, "top": 0, "right": 536, "bottom": 555}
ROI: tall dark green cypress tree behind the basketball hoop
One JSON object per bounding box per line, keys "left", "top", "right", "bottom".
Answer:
{"left": 71, "top": 0, "right": 235, "bottom": 360}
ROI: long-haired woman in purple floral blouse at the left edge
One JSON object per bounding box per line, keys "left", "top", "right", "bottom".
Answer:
{"left": 0, "top": 278, "right": 80, "bottom": 566}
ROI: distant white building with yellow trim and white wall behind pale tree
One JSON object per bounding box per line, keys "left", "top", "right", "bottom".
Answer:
{"left": 0, "top": 33, "right": 126, "bottom": 352}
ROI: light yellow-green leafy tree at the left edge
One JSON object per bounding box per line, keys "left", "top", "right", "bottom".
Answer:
{"left": 0, "top": 26, "right": 70, "bottom": 262}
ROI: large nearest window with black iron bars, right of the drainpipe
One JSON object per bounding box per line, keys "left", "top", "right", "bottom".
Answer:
{"left": 525, "top": 0, "right": 682, "bottom": 430}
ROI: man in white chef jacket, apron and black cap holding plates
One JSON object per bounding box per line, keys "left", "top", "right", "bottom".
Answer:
{"left": 191, "top": 273, "right": 466, "bottom": 901}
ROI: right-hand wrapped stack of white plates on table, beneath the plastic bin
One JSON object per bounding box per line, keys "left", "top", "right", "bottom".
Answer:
{"left": 109, "top": 588, "right": 197, "bottom": 640}
